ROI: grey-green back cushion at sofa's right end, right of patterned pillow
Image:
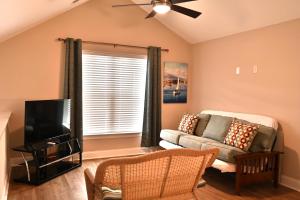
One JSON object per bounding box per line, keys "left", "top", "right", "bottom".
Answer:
{"left": 249, "top": 125, "right": 277, "bottom": 152}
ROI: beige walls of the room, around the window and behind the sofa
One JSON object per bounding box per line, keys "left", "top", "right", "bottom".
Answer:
{"left": 0, "top": 0, "right": 300, "bottom": 183}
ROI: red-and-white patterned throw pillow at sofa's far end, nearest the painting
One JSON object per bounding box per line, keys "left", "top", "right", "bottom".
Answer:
{"left": 178, "top": 114, "right": 199, "bottom": 134}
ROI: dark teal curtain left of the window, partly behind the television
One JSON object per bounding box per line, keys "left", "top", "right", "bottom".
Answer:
{"left": 64, "top": 38, "right": 83, "bottom": 151}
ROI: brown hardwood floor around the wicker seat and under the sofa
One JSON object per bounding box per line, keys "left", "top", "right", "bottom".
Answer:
{"left": 8, "top": 157, "right": 300, "bottom": 200}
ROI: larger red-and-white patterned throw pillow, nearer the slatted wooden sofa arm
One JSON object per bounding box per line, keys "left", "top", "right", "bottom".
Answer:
{"left": 224, "top": 119, "right": 258, "bottom": 151}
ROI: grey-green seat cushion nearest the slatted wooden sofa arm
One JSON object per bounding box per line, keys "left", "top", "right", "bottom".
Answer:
{"left": 201, "top": 142, "right": 246, "bottom": 163}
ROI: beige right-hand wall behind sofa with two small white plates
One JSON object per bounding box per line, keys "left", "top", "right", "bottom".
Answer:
{"left": 189, "top": 20, "right": 300, "bottom": 179}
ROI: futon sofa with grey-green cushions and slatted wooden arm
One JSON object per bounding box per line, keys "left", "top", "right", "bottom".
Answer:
{"left": 159, "top": 110, "right": 279, "bottom": 193}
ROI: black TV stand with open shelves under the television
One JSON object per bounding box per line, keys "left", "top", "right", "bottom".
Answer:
{"left": 12, "top": 135, "right": 82, "bottom": 185}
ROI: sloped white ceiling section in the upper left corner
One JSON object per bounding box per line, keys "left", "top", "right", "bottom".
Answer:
{"left": 0, "top": 0, "right": 87, "bottom": 42}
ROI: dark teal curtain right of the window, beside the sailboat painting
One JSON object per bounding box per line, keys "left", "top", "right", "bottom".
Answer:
{"left": 141, "top": 47, "right": 161, "bottom": 147}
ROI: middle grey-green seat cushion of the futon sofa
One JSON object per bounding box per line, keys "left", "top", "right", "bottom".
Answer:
{"left": 179, "top": 134, "right": 216, "bottom": 150}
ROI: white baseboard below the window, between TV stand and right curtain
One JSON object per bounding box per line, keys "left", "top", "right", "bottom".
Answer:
{"left": 82, "top": 148, "right": 145, "bottom": 160}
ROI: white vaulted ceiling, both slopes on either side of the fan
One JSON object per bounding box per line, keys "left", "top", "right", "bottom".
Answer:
{"left": 0, "top": 0, "right": 300, "bottom": 43}
